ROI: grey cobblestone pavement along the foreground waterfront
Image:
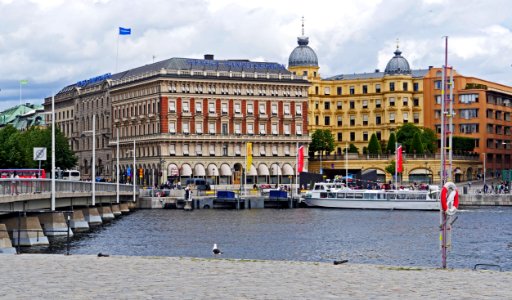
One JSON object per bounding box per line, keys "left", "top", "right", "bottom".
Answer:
{"left": 0, "top": 254, "right": 512, "bottom": 299}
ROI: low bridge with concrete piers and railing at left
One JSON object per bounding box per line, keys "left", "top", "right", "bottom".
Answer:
{"left": 0, "top": 178, "right": 138, "bottom": 253}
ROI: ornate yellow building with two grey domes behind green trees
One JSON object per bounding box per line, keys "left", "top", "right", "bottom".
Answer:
{"left": 288, "top": 36, "right": 428, "bottom": 154}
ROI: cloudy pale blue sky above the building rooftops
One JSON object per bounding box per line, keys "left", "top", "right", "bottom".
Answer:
{"left": 0, "top": 0, "right": 512, "bottom": 110}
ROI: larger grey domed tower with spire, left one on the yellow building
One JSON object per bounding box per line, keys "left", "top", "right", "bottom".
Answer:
{"left": 288, "top": 18, "right": 319, "bottom": 79}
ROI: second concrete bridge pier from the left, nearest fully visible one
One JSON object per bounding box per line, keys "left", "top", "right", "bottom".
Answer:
{"left": 5, "top": 217, "right": 50, "bottom": 246}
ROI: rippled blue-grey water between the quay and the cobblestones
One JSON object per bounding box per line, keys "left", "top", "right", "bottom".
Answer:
{"left": 30, "top": 207, "right": 512, "bottom": 270}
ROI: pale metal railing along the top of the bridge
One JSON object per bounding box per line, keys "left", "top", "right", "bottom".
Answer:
{"left": 0, "top": 178, "right": 133, "bottom": 196}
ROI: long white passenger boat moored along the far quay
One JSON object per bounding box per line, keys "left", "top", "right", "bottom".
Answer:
{"left": 304, "top": 182, "right": 440, "bottom": 210}
